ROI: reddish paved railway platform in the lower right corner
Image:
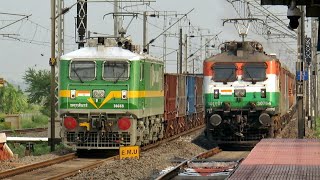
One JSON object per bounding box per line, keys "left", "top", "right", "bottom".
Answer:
{"left": 228, "top": 139, "right": 320, "bottom": 180}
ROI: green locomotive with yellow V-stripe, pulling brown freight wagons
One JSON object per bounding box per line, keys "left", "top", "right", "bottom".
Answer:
{"left": 59, "top": 40, "right": 204, "bottom": 149}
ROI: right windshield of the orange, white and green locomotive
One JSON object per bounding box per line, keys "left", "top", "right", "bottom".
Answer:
{"left": 242, "top": 63, "right": 267, "bottom": 83}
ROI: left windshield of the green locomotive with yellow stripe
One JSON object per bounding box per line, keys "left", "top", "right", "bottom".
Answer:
{"left": 69, "top": 61, "right": 96, "bottom": 82}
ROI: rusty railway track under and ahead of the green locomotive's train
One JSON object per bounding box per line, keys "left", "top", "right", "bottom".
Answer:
{"left": 0, "top": 125, "right": 204, "bottom": 180}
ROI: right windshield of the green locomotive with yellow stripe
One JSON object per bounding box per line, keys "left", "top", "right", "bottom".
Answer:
{"left": 103, "top": 61, "right": 129, "bottom": 82}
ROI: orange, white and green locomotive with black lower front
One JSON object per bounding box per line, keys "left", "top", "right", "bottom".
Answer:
{"left": 203, "top": 41, "right": 295, "bottom": 143}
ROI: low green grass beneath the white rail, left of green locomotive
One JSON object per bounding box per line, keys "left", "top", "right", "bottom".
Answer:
{"left": 8, "top": 142, "right": 66, "bottom": 158}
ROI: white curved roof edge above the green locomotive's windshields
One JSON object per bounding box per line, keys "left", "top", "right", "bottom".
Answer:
{"left": 61, "top": 46, "right": 162, "bottom": 62}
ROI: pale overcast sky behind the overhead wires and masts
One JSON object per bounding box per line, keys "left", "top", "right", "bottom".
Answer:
{"left": 0, "top": 0, "right": 294, "bottom": 86}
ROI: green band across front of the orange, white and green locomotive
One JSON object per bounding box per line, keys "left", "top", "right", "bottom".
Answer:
{"left": 204, "top": 92, "right": 280, "bottom": 109}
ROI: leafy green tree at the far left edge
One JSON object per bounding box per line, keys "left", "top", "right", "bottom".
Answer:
{"left": 0, "top": 83, "right": 28, "bottom": 114}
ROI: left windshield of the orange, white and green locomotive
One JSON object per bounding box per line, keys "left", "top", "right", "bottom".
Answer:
{"left": 212, "top": 64, "right": 236, "bottom": 83}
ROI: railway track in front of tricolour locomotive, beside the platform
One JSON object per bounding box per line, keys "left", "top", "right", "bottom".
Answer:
{"left": 156, "top": 148, "right": 249, "bottom": 180}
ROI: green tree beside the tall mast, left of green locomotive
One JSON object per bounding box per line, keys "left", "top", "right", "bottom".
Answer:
{"left": 23, "top": 68, "right": 51, "bottom": 116}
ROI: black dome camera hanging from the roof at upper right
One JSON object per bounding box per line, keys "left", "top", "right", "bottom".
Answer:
{"left": 287, "top": 0, "right": 301, "bottom": 30}
